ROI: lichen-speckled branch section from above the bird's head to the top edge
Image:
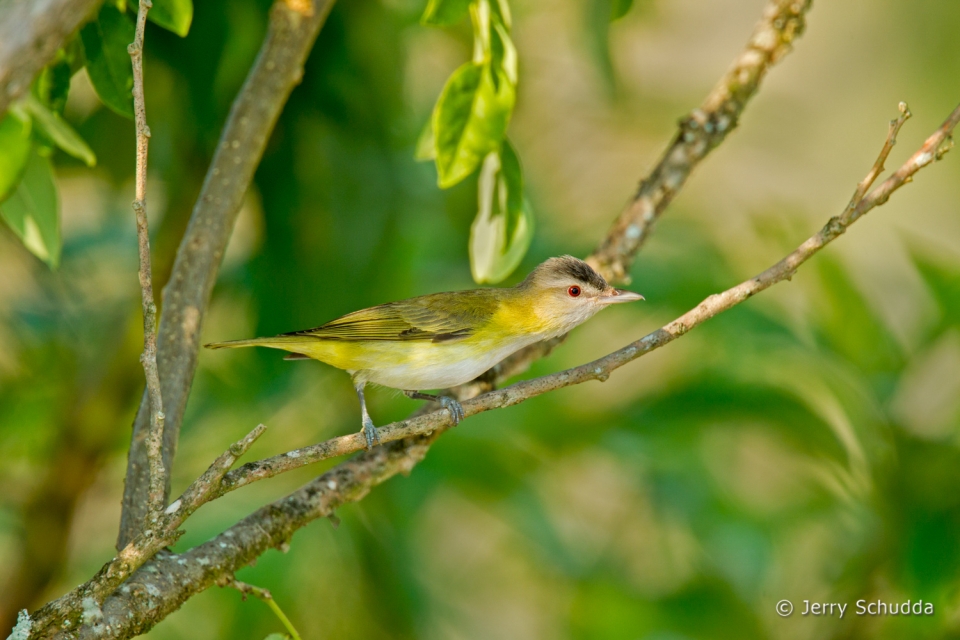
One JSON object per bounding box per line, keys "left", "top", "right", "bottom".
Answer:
{"left": 587, "top": 0, "right": 811, "bottom": 282}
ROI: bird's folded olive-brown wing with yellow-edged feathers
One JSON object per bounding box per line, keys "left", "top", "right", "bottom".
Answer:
{"left": 285, "top": 289, "right": 499, "bottom": 342}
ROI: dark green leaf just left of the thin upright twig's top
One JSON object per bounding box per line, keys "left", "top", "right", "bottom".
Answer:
{"left": 80, "top": 4, "right": 134, "bottom": 119}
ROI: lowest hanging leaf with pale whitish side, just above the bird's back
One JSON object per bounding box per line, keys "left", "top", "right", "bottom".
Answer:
{"left": 470, "top": 140, "right": 534, "bottom": 284}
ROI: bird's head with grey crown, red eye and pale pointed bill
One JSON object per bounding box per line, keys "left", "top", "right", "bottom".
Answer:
{"left": 517, "top": 256, "right": 644, "bottom": 333}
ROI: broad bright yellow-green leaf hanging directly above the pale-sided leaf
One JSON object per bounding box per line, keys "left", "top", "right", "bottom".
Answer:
{"left": 433, "top": 62, "right": 516, "bottom": 189}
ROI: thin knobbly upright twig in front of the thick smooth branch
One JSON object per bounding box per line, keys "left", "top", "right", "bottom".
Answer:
{"left": 127, "top": 0, "right": 166, "bottom": 515}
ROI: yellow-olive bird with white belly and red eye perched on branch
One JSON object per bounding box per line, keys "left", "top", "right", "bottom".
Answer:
{"left": 204, "top": 255, "right": 644, "bottom": 450}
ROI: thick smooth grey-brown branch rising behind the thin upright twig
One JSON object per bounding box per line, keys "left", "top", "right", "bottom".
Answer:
{"left": 117, "top": 0, "right": 333, "bottom": 549}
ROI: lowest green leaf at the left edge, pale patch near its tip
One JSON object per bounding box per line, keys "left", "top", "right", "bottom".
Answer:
{"left": 0, "top": 152, "right": 60, "bottom": 269}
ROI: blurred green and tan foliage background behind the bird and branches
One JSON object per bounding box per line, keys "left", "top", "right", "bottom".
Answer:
{"left": 0, "top": 0, "right": 960, "bottom": 640}
